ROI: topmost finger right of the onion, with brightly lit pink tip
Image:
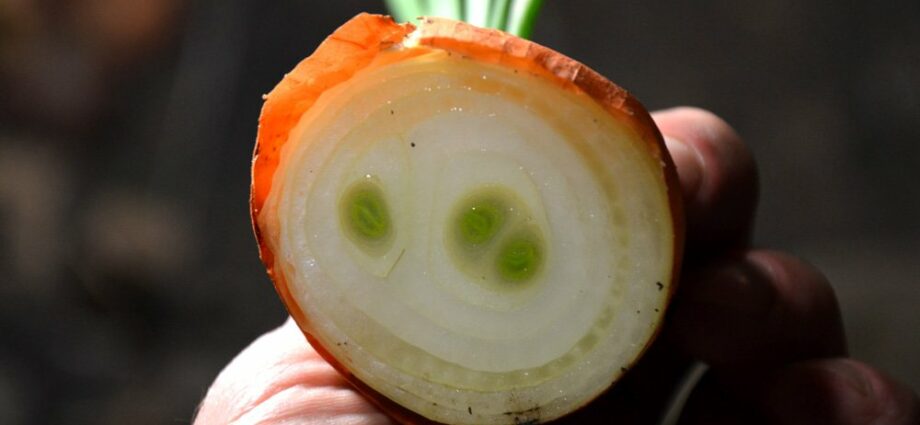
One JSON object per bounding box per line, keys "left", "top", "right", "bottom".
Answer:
{"left": 652, "top": 108, "right": 758, "bottom": 255}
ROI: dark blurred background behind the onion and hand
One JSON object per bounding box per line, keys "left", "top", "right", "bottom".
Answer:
{"left": 0, "top": 0, "right": 920, "bottom": 425}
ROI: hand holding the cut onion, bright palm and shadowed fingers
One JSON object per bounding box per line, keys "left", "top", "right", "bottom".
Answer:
{"left": 195, "top": 108, "right": 920, "bottom": 425}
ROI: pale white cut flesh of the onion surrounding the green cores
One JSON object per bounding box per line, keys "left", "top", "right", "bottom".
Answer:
{"left": 260, "top": 53, "right": 674, "bottom": 423}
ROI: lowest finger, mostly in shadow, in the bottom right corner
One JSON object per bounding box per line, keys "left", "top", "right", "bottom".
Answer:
{"left": 762, "top": 359, "right": 920, "bottom": 425}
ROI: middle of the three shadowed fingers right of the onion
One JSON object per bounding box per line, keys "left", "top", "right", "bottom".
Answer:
{"left": 668, "top": 251, "right": 846, "bottom": 367}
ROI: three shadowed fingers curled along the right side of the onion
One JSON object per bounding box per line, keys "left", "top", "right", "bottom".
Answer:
{"left": 608, "top": 108, "right": 920, "bottom": 425}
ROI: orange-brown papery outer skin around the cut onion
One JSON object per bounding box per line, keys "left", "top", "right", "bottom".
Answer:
{"left": 250, "top": 13, "right": 685, "bottom": 424}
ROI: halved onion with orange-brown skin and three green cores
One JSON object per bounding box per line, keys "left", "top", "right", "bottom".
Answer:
{"left": 251, "top": 14, "right": 683, "bottom": 424}
